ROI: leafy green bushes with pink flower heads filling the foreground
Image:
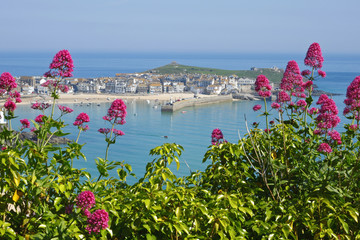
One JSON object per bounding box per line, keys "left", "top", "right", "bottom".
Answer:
{"left": 0, "top": 43, "right": 360, "bottom": 240}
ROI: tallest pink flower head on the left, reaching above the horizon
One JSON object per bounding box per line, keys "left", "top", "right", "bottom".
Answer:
{"left": 44, "top": 50, "right": 74, "bottom": 77}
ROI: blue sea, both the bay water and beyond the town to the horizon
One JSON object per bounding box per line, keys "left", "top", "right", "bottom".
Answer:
{"left": 0, "top": 52, "right": 360, "bottom": 183}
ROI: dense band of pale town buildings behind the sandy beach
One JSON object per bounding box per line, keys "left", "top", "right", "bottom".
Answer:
{"left": 17, "top": 73, "right": 262, "bottom": 95}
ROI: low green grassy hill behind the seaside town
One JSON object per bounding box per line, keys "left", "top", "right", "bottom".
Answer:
{"left": 146, "top": 62, "right": 284, "bottom": 82}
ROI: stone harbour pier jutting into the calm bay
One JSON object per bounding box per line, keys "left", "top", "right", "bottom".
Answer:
{"left": 161, "top": 95, "right": 233, "bottom": 112}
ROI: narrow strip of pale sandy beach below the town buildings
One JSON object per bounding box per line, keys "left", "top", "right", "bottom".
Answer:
{"left": 11, "top": 93, "right": 214, "bottom": 104}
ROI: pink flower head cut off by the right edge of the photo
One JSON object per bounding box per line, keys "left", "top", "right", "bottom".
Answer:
{"left": 344, "top": 76, "right": 360, "bottom": 121}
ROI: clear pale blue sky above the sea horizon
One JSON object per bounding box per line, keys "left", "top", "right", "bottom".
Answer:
{"left": 0, "top": 0, "right": 360, "bottom": 54}
